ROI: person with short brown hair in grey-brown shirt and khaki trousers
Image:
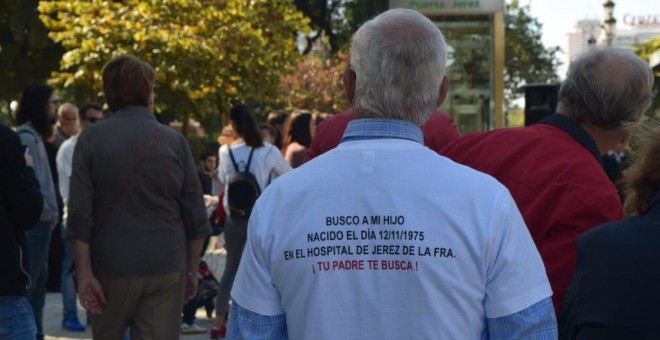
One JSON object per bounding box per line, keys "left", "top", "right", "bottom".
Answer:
{"left": 67, "top": 56, "right": 210, "bottom": 339}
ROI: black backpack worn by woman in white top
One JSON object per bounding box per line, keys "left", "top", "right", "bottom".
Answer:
{"left": 225, "top": 147, "right": 261, "bottom": 219}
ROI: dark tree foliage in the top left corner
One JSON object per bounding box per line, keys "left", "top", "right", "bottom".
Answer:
{"left": 0, "top": 0, "right": 64, "bottom": 106}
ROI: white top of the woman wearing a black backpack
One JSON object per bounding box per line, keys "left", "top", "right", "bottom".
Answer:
{"left": 218, "top": 142, "right": 291, "bottom": 214}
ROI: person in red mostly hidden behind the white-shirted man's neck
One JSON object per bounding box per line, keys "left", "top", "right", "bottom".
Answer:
{"left": 303, "top": 109, "right": 462, "bottom": 163}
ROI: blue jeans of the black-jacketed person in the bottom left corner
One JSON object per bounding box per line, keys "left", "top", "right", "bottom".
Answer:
{"left": 0, "top": 296, "right": 37, "bottom": 340}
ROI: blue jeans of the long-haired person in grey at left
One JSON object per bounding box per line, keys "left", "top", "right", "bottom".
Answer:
{"left": 25, "top": 221, "right": 51, "bottom": 340}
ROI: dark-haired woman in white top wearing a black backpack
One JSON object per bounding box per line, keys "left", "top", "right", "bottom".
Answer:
{"left": 211, "top": 104, "right": 291, "bottom": 338}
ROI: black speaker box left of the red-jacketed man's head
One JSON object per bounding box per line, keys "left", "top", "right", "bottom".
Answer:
{"left": 525, "top": 83, "right": 560, "bottom": 126}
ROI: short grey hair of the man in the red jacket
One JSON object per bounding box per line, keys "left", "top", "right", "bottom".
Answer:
{"left": 558, "top": 48, "right": 653, "bottom": 132}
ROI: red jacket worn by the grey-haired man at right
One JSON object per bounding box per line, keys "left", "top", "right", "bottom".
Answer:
{"left": 441, "top": 117, "right": 623, "bottom": 312}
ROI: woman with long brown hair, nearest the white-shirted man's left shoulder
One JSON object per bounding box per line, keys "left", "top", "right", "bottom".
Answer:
{"left": 282, "top": 112, "right": 316, "bottom": 169}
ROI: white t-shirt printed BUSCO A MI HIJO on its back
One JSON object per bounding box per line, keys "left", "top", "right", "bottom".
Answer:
{"left": 232, "top": 139, "right": 552, "bottom": 339}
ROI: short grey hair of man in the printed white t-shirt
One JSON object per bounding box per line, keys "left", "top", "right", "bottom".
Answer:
{"left": 351, "top": 9, "right": 447, "bottom": 126}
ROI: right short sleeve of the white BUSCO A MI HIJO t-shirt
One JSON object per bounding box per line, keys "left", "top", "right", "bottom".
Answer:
{"left": 484, "top": 190, "right": 552, "bottom": 318}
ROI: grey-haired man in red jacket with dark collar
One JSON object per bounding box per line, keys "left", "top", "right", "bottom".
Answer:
{"left": 441, "top": 48, "right": 653, "bottom": 311}
